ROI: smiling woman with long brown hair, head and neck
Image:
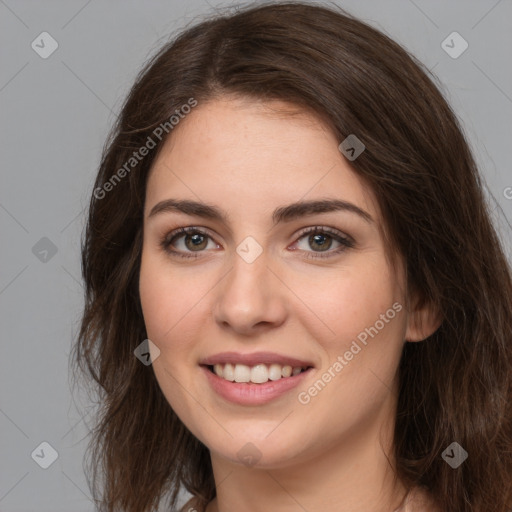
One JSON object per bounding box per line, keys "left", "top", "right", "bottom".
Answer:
{"left": 74, "top": 2, "right": 512, "bottom": 512}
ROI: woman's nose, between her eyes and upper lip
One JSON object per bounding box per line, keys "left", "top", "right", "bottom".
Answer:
{"left": 213, "top": 252, "right": 291, "bottom": 336}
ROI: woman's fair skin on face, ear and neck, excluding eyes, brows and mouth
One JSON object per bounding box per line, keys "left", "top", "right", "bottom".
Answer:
{"left": 140, "top": 97, "right": 438, "bottom": 512}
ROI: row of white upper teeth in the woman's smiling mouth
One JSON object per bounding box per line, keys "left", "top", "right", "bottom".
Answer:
{"left": 209, "top": 363, "right": 306, "bottom": 384}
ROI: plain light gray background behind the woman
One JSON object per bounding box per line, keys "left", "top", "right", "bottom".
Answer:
{"left": 0, "top": 0, "right": 512, "bottom": 512}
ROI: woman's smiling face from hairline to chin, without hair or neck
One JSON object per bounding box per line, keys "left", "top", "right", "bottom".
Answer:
{"left": 140, "top": 99, "right": 411, "bottom": 467}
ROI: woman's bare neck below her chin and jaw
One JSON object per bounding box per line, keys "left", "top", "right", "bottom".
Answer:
{"left": 206, "top": 392, "right": 406, "bottom": 512}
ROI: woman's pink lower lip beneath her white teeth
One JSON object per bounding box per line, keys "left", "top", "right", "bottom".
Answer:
{"left": 201, "top": 366, "right": 313, "bottom": 405}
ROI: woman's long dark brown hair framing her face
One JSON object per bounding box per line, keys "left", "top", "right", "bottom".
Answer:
{"left": 72, "top": 2, "right": 512, "bottom": 512}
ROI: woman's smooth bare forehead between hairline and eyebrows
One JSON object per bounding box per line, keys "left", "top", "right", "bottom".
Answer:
{"left": 145, "top": 98, "right": 378, "bottom": 223}
